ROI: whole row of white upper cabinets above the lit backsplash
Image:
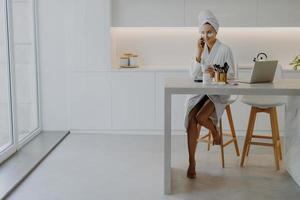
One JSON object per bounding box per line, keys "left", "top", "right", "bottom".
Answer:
{"left": 111, "top": 0, "right": 300, "bottom": 27}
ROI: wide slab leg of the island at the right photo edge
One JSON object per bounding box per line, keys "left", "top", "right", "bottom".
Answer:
{"left": 284, "top": 96, "right": 300, "bottom": 186}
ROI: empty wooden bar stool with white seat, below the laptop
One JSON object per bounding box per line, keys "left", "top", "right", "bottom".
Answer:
{"left": 241, "top": 96, "right": 285, "bottom": 170}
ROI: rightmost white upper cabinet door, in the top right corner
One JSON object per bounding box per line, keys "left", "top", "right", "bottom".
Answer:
{"left": 257, "top": 0, "right": 300, "bottom": 27}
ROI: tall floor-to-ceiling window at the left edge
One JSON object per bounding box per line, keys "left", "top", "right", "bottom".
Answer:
{"left": 0, "top": 0, "right": 41, "bottom": 162}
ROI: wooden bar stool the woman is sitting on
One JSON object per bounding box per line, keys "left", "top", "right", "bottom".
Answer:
{"left": 198, "top": 101, "right": 240, "bottom": 168}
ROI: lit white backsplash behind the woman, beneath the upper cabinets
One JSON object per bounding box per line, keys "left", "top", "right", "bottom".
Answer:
{"left": 111, "top": 27, "right": 300, "bottom": 68}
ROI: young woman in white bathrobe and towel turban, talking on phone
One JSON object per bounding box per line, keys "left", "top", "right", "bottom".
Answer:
{"left": 185, "top": 10, "right": 235, "bottom": 178}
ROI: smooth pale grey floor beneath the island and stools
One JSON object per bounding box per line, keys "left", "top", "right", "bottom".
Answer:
{"left": 8, "top": 134, "right": 300, "bottom": 200}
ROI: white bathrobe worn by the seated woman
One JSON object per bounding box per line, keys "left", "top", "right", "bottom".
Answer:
{"left": 184, "top": 40, "right": 235, "bottom": 128}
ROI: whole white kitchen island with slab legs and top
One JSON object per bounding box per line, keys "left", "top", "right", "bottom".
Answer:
{"left": 164, "top": 78, "right": 300, "bottom": 194}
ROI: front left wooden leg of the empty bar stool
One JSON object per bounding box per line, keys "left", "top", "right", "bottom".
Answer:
{"left": 240, "top": 107, "right": 257, "bottom": 167}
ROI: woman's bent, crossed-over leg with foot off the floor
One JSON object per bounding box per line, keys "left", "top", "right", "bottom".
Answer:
{"left": 196, "top": 100, "right": 221, "bottom": 144}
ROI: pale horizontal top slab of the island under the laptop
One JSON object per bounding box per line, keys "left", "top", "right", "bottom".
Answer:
{"left": 165, "top": 78, "right": 300, "bottom": 96}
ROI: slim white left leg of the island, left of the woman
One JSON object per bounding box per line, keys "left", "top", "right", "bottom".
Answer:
{"left": 164, "top": 90, "right": 172, "bottom": 194}
